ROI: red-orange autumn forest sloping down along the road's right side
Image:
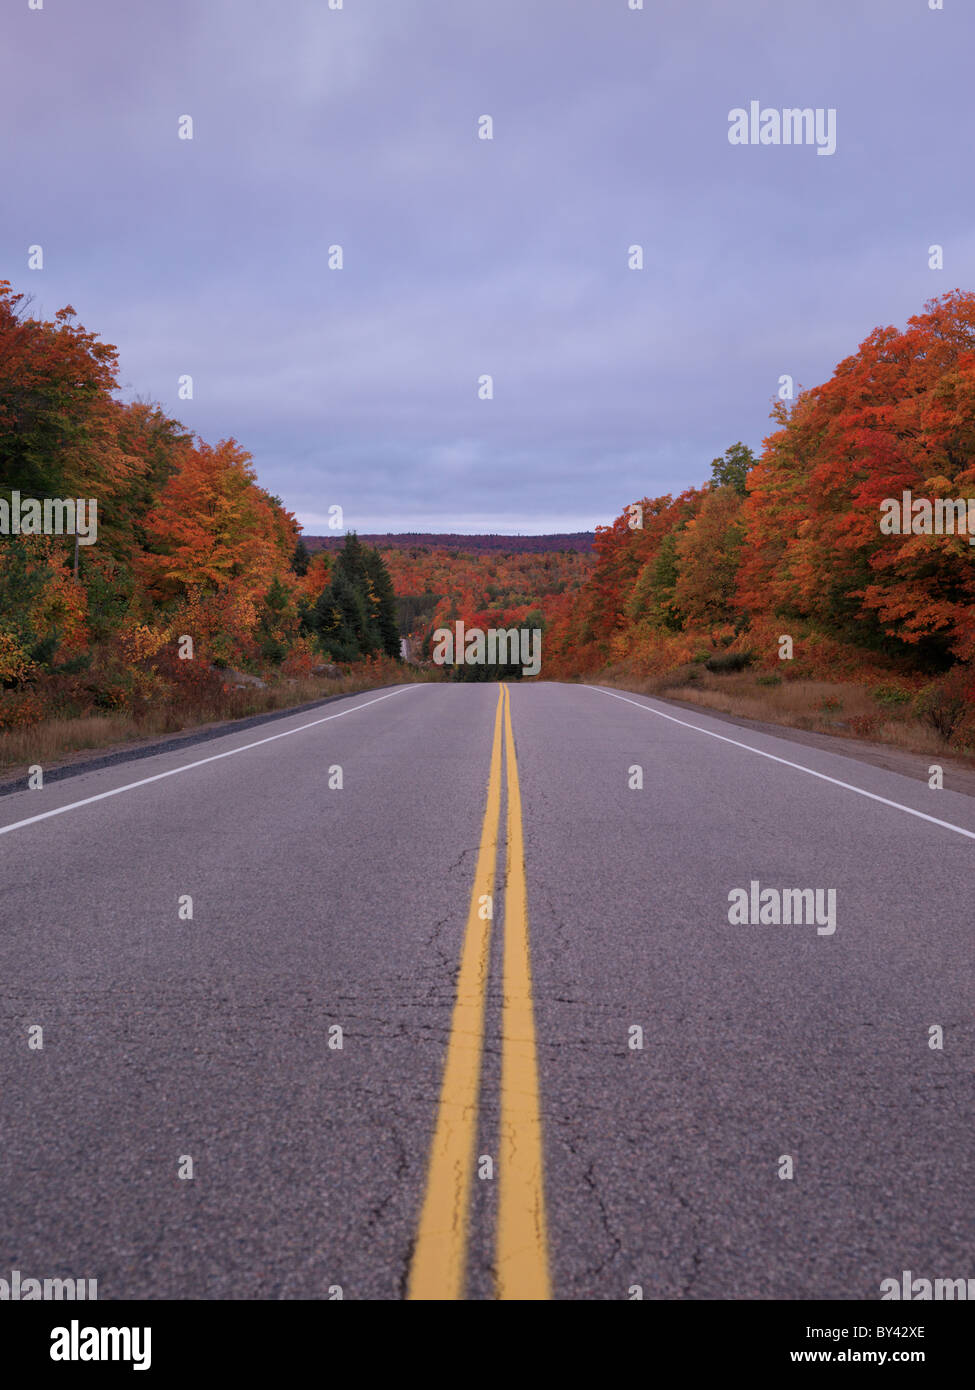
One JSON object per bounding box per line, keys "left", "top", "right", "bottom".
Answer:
{"left": 544, "top": 291, "right": 975, "bottom": 748}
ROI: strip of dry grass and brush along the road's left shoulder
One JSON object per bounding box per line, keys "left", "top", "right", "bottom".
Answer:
{"left": 0, "top": 667, "right": 440, "bottom": 776}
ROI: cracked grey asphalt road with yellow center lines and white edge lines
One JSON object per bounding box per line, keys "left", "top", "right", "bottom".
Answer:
{"left": 0, "top": 682, "right": 975, "bottom": 1300}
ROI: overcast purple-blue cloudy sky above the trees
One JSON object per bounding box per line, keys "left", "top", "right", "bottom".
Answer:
{"left": 0, "top": 0, "right": 975, "bottom": 532}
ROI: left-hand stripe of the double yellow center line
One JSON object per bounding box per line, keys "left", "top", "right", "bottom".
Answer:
{"left": 408, "top": 687, "right": 503, "bottom": 1300}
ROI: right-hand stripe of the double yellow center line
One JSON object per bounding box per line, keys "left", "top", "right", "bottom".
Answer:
{"left": 497, "top": 687, "right": 551, "bottom": 1300}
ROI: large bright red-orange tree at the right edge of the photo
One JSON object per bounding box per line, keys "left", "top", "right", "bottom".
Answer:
{"left": 739, "top": 291, "right": 975, "bottom": 664}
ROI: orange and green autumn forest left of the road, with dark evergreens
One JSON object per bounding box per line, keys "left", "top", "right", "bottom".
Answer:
{"left": 0, "top": 281, "right": 399, "bottom": 760}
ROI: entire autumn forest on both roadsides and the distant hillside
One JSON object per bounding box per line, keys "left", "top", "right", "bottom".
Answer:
{"left": 0, "top": 281, "right": 975, "bottom": 767}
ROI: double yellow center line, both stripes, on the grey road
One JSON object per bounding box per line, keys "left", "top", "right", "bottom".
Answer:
{"left": 409, "top": 685, "right": 551, "bottom": 1300}
